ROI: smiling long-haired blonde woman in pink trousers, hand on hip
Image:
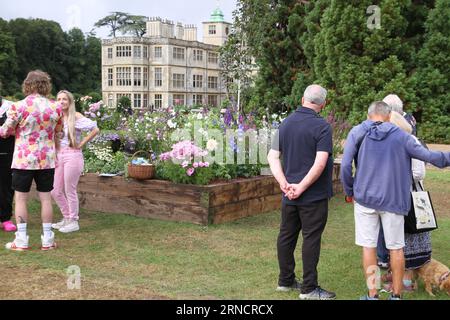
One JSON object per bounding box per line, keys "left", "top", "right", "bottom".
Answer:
{"left": 52, "top": 90, "right": 100, "bottom": 233}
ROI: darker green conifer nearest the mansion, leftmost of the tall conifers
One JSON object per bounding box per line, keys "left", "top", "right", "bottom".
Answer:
{"left": 239, "top": 0, "right": 307, "bottom": 111}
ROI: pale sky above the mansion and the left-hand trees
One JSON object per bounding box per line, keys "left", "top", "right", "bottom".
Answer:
{"left": 0, "top": 0, "right": 237, "bottom": 38}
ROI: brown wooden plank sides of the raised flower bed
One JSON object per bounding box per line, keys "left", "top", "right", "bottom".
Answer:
{"left": 32, "top": 164, "right": 342, "bottom": 225}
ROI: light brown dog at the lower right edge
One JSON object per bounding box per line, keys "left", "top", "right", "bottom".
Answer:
{"left": 415, "top": 259, "right": 450, "bottom": 297}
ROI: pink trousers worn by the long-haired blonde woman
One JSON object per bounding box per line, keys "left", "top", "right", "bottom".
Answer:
{"left": 52, "top": 148, "right": 84, "bottom": 221}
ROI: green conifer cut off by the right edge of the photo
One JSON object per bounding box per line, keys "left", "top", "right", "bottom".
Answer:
{"left": 414, "top": 0, "right": 450, "bottom": 143}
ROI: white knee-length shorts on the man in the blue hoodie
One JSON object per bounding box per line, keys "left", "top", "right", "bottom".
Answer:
{"left": 355, "top": 202, "right": 405, "bottom": 250}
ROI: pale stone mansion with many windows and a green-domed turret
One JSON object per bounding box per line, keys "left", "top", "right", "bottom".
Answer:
{"left": 102, "top": 10, "right": 231, "bottom": 109}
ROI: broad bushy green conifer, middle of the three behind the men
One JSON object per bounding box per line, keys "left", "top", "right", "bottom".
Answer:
{"left": 306, "top": 0, "right": 415, "bottom": 123}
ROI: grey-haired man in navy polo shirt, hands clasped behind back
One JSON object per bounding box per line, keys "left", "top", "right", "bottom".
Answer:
{"left": 268, "top": 85, "right": 336, "bottom": 300}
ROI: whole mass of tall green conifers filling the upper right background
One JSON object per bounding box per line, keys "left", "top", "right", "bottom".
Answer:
{"left": 235, "top": 0, "right": 450, "bottom": 142}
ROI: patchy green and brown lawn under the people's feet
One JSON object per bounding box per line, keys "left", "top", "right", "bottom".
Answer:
{"left": 0, "top": 171, "right": 450, "bottom": 300}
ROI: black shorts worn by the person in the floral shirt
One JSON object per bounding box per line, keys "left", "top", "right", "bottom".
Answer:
{"left": 12, "top": 169, "right": 55, "bottom": 193}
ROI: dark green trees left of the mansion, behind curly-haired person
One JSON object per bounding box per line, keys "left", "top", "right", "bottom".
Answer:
{"left": 0, "top": 18, "right": 101, "bottom": 95}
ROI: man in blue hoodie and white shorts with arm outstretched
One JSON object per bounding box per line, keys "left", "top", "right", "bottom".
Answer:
{"left": 341, "top": 102, "right": 450, "bottom": 300}
